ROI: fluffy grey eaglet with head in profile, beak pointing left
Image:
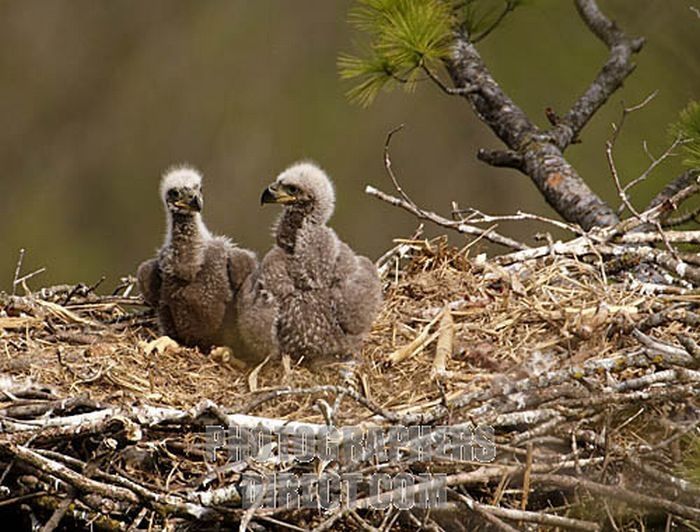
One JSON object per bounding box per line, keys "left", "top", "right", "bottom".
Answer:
{"left": 239, "top": 162, "right": 382, "bottom": 362}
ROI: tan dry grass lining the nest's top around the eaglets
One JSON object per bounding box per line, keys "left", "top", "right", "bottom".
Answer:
{"left": 0, "top": 240, "right": 660, "bottom": 423}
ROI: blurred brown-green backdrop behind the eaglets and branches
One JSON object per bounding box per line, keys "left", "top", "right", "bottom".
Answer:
{"left": 0, "top": 0, "right": 700, "bottom": 290}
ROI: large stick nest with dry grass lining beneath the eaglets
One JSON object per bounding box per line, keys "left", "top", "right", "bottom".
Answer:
{"left": 0, "top": 238, "right": 700, "bottom": 530}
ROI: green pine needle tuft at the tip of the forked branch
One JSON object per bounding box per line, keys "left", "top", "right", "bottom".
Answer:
{"left": 338, "top": 0, "right": 452, "bottom": 106}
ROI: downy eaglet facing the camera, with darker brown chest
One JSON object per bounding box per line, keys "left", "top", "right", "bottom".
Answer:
{"left": 137, "top": 166, "right": 257, "bottom": 349}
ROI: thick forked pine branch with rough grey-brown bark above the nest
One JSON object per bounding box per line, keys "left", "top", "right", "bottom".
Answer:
{"left": 446, "top": 0, "right": 643, "bottom": 230}
